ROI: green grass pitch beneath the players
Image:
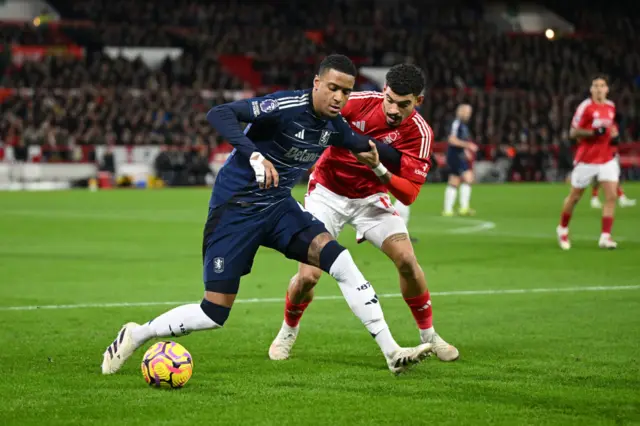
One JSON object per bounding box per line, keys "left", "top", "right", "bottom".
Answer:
{"left": 0, "top": 184, "right": 640, "bottom": 426}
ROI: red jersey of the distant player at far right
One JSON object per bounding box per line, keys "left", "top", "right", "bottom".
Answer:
{"left": 571, "top": 98, "right": 616, "bottom": 164}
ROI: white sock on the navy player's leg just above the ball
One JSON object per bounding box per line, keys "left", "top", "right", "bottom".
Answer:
{"left": 131, "top": 303, "right": 220, "bottom": 346}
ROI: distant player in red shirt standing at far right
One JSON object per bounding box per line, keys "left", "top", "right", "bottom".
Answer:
{"left": 556, "top": 75, "right": 620, "bottom": 250}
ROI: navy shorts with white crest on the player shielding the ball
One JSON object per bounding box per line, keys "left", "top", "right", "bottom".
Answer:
{"left": 202, "top": 197, "right": 327, "bottom": 287}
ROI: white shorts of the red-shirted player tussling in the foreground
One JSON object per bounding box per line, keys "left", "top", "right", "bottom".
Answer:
{"left": 304, "top": 183, "right": 409, "bottom": 248}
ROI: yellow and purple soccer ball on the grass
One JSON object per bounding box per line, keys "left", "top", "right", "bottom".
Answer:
{"left": 141, "top": 342, "right": 193, "bottom": 389}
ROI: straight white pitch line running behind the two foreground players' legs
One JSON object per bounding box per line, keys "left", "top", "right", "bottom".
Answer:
{"left": 0, "top": 285, "right": 640, "bottom": 311}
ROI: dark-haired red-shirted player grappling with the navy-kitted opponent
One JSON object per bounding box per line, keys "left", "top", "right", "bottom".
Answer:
{"left": 269, "top": 64, "right": 459, "bottom": 361}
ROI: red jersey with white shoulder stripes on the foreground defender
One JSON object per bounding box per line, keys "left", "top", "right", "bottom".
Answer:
{"left": 312, "top": 92, "right": 433, "bottom": 198}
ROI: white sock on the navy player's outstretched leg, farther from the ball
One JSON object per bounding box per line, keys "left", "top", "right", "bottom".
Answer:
{"left": 329, "top": 250, "right": 400, "bottom": 357}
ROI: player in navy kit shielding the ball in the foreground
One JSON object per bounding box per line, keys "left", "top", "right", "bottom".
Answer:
{"left": 102, "top": 55, "right": 433, "bottom": 374}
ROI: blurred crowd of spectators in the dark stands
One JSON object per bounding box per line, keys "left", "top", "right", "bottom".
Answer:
{"left": 0, "top": 0, "right": 640, "bottom": 179}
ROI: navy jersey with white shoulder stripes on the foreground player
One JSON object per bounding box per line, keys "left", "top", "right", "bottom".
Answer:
{"left": 209, "top": 89, "right": 340, "bottom": 208}
